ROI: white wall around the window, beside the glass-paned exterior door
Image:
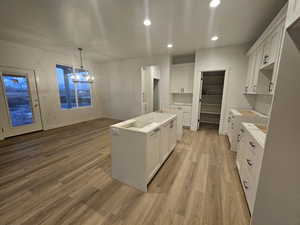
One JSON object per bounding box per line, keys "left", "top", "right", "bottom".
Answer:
{"left": 0, "top": 41, "right": 102, "bottom": 132}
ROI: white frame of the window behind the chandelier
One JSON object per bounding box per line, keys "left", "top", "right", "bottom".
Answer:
{"left": 54, "top": 62, "right": 94, "bottom": 111}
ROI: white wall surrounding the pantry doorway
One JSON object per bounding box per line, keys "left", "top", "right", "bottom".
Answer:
{"left": 192, "top": 45, "right": 255, "bottom": 132}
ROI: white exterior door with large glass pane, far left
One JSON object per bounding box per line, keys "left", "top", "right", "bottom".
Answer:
{"left": 0, "top": 68, "right": 42, "bottom": 137}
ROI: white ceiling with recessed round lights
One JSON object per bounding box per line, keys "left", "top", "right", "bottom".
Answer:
{"left": 0, "top": 0, "right": 286, "bottom": 61}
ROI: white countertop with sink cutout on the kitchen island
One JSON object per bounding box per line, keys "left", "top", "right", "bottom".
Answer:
{"left": 111, "top": 112, "right": 176, "bottom": 133}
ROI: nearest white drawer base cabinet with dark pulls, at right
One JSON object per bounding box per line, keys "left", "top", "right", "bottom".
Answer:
{"left": 236, "top": 123, "right": 264, "bottom": 214}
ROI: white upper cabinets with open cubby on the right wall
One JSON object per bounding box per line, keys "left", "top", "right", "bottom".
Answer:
{"left": 245, "top": 5, "right": 288, "bottom": 95}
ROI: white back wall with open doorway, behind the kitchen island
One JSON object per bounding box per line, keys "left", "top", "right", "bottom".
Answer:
{"left": 96, "top": 55, "right": 170, "bottom": 120}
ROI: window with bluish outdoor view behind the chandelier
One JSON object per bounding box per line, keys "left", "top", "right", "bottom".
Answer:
{"left": 56, "top": 65, "right": 92, "bottom": 109}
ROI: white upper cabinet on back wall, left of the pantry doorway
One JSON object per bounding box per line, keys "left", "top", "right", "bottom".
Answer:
{"left": 171, "top": 63, "right": 194, "bottom": 94}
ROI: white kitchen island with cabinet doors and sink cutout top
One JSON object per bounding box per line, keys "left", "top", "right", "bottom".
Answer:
{"left": 111, "top": 112, "right": 177, "bottom": 192}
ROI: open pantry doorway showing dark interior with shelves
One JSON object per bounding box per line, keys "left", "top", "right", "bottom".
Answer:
{"left": 198, "top": 70, "right": 225, "bottom": 129}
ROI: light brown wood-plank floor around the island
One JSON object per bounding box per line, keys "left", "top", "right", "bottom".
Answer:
{"left": 0, "top": 119, "right": 249, "bottom": 225}
